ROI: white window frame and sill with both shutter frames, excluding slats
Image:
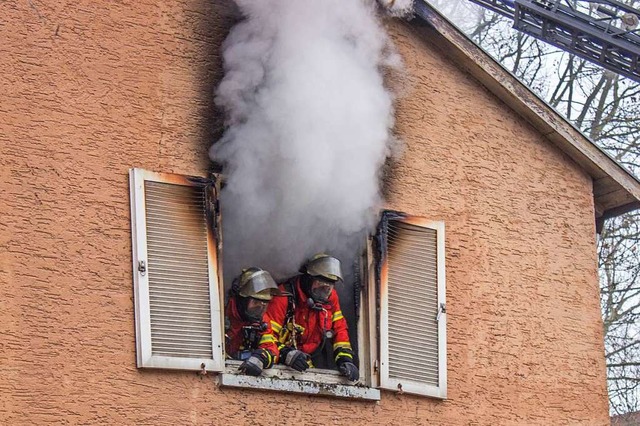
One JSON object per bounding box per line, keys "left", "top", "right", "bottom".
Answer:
{"left": 129, "top": 168, "right": 447, "bottom": 401}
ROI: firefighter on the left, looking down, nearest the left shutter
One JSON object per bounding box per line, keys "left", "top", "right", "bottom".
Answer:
{"left": 225, "top": 268, "right": 280, "bottom": 376}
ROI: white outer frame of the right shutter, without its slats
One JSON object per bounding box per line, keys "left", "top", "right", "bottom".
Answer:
{"left": 379, "top": 216, "right": 447, "bottom": 399}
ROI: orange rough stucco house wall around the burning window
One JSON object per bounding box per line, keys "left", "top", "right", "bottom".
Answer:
{"left": 0, "top": 0, "right": 607, "bottom": 425}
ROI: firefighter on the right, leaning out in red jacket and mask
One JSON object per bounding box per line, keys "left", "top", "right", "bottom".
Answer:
{"left": 266, "top": 254, "right": 359, "bottom": 381}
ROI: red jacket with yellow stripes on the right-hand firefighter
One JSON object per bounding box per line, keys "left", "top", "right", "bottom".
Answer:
{"left": 265, "top": 277, "right": 353, "bottom": 361}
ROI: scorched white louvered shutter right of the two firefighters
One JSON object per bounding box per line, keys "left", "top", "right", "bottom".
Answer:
{"left": 380, "top": 217, "right": 447, "bottom": 398}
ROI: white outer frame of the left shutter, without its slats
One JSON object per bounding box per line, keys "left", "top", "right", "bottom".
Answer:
{"left": 129, "top": 168, "right": 224, "bottom": 371}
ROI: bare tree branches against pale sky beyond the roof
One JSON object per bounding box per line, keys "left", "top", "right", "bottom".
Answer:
{"left": 429, "top": 0, "right": 640, "bottom": 414}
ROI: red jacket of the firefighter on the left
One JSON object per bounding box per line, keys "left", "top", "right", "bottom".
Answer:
{"left": 225, "top": 297, "right": 278, "bottom": 368}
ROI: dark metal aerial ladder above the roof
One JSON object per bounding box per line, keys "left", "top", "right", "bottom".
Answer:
{"left": 416, "top": 0, "right": 640, "bottom": 83}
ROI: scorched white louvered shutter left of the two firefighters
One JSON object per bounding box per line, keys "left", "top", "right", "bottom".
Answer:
{"left": 130, "top": 169, "right": 224, "bottom": 371}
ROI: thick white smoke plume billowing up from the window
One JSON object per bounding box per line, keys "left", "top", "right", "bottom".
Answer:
{"left": 210, "top": 0, "right": 400, "bottom": 281}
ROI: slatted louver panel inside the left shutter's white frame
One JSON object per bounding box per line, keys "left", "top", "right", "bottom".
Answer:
{"left": 145, "top": 181, "right": 213, "bottom": 358}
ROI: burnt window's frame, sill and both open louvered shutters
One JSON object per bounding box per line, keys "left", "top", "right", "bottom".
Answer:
{"left": 130, "top": 169, "right": 446, "bottom": 400}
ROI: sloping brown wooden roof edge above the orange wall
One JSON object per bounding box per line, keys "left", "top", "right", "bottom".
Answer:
{"left": 409, "top": 0, "right": 640, "bottom": 218}
